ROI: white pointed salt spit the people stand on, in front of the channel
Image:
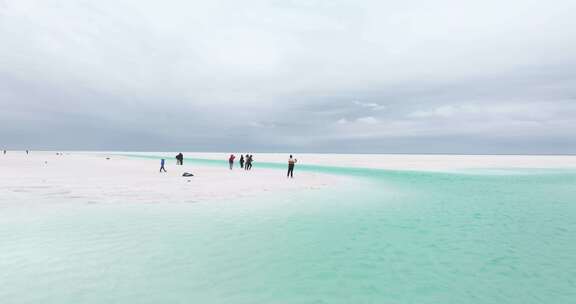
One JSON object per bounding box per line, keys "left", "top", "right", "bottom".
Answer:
{"left": 0, "top": 152, "right": 346, "bottom": 203}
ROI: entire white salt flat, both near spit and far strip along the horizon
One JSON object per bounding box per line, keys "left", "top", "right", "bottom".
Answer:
{"left": 0, "top": 151, "right": 576, "bottom": 203}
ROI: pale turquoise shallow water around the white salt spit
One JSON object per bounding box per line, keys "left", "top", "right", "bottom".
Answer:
{"left": 0, "top": 156, "right": 576, "bottom": 303}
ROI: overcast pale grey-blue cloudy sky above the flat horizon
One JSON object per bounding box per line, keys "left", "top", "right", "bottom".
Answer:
{"left": 0, "top": 0, "right": 576, "bottom": 153}
